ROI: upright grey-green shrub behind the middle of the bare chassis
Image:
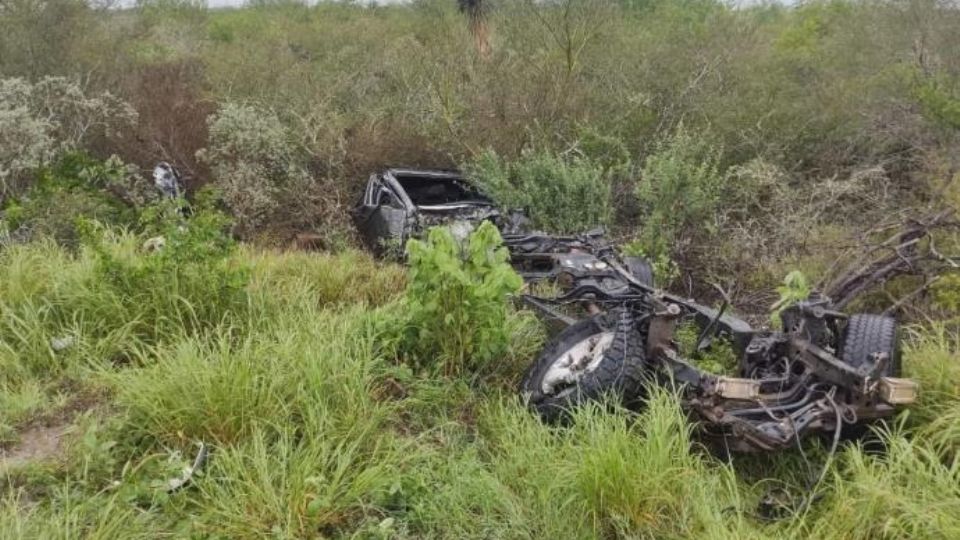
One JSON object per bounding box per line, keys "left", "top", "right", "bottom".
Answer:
{"left": 636, "top": 127, "right": 724, "bottom": 260}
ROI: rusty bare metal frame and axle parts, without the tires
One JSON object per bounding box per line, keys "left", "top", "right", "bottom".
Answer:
{"left": 543, "top": 285, "right": 917, "bottom": 451}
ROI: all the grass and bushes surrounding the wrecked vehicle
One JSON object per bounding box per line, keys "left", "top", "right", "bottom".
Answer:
{"left": 0, "top": 0, "right": 960, "bottom": 538}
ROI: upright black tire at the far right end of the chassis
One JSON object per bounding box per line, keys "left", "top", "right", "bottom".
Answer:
{"left": 840, "top": 313, "right": 901, "bottom": 377}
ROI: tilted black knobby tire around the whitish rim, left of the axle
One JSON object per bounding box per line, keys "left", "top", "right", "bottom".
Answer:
{"left": 520, "top": 310, "right": 644, "bottom": 423}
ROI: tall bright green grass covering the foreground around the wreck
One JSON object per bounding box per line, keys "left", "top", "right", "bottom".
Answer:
{"left": 0, "top": 241, "right": 960, "bottom": 539}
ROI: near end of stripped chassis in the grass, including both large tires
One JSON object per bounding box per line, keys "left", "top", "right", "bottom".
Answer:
{"left": 521, "top": 270, "right": 917, "bottom": 451}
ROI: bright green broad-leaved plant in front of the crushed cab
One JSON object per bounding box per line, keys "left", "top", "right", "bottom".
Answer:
{"left": 402, "top": 222, "right": 522, "bottom": 376}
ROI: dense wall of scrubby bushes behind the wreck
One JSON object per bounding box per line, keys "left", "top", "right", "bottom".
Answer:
{"left": 0, "top": 0, "right": 960, "bottom": 281}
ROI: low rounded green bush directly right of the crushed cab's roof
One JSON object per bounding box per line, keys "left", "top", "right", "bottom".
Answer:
{"left": 466, "top": 149, "right": 616, "bottom": 233}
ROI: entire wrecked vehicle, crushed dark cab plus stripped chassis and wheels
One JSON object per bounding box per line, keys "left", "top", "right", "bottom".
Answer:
{"left": 354, "top": 169, "right": 917, "bottom": 451}
